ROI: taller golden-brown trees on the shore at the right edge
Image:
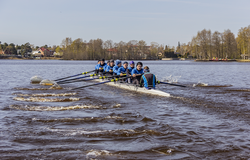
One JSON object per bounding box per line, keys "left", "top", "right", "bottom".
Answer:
{"left": 176, "top": 25, "right": 250, "bottom": 59}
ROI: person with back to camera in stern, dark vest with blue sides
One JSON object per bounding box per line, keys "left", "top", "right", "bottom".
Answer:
{"left": 140, "top": 66, "right": 156, "bottom": 89}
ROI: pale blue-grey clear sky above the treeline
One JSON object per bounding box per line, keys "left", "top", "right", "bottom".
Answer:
{"left": 0, "top": 0, "right": 250, "bottom": 46}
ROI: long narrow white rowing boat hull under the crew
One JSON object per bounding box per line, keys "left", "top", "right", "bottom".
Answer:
{"left": 94, "top": 79, "right": 170, "bottom": 97}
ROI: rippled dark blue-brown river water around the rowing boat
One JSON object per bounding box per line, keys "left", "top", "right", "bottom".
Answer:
{"left": 0, "top": 60, "right": 250, "bottom": 160}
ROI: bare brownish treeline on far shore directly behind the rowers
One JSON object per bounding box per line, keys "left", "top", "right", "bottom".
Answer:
{"left": 56, "top": 38, "right": 164, "bottom": 60}
